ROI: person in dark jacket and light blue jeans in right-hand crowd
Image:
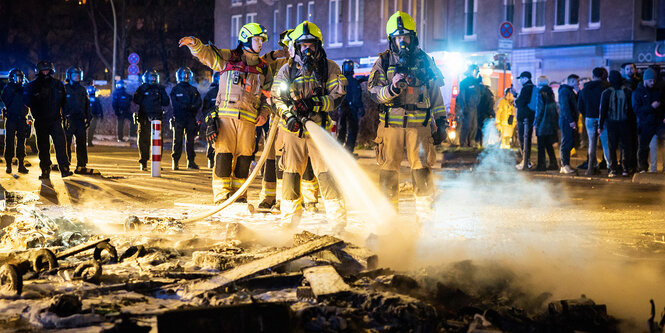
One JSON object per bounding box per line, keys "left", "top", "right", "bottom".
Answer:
{"left": 578, "top": 67, "right": 609, "bottom": 176}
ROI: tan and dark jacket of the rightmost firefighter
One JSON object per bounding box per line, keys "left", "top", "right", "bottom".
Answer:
{"left": 367, "top": 49, "right": 446, "bottom": 127}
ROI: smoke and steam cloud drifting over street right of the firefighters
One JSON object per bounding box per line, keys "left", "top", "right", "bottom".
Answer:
{"left": 411, "top": 124, "right": 665, "bottom": 322}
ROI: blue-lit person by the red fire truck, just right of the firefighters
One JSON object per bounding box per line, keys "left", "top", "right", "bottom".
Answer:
{"left": 455, "top": 65, "right": 482, "bottom": 147}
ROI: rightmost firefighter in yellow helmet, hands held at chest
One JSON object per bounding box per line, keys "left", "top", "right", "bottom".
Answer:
{"left": 367, "top": 11, "right": 446, "bottom": 213}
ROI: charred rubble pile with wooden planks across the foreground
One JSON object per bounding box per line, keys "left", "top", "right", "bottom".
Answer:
{"left": 0, "top": 209, "right": 618, "bottom": 332}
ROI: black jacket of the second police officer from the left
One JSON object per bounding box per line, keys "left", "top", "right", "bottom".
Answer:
{"left": 23, "top": 74, "right": 65, "bottom": 124}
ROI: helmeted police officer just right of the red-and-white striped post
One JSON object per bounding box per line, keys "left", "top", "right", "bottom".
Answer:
{"left": 171, "top": 67, "right": 201, "bottom": 170}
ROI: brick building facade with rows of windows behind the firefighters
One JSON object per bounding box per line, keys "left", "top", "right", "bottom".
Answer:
{"left": 215, "top": 0, "right": 665, "bottom": 96}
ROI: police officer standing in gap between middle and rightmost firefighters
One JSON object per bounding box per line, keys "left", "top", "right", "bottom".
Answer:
{"left": 337, "top": 60, "right": 367, "bottom": 153}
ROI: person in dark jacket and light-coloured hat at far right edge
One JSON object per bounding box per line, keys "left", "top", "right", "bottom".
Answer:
{"left": 632, "top": 68, "right": 663, "bottom": 173}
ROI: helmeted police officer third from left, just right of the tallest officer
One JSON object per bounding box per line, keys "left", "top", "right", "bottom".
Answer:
{"left": 62, "top": 67, "right": 90, "bottom": 174}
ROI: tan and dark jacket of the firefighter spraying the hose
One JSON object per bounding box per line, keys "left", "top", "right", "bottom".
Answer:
{"left": 270, "top": 56, "right": 346, "bottom": 134}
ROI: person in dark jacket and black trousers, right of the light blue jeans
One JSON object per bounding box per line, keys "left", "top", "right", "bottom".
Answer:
{"left": 600, "top": 71, "right": 635, "bottom": 178}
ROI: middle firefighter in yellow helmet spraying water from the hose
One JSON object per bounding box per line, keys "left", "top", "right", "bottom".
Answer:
{"left": 271, "top": 21, "right": 346, "bottom": 232}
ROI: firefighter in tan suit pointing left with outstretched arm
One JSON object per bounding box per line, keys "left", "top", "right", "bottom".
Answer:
{"left": 180, "top": 23, "right": 273, "bottom": 204}
